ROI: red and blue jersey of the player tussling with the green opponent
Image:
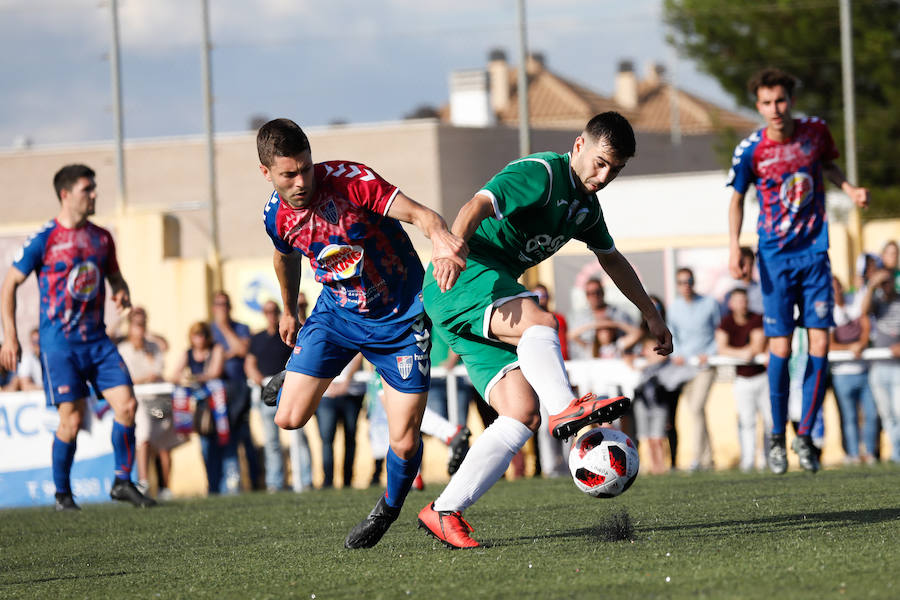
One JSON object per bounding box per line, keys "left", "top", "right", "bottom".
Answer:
{"left": 263, "top": 161, "right": 424, "bottom": 320}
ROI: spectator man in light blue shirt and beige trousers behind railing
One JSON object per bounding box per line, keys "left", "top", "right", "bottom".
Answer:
{"left": 668, "top": 267, "right": 719, "bottom": 471}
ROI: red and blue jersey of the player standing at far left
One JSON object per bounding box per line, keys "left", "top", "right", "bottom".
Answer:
{"left": 13, "top": 219, "right": 119, "bottom": 350}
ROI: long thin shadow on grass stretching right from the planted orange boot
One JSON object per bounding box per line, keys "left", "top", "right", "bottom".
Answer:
{"left": 483, "top": 508, "right": 900, "bottom": 547}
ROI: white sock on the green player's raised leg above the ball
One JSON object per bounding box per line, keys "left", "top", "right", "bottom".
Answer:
{"left": 516, "top": 325, "right": 575, "bottom": 415}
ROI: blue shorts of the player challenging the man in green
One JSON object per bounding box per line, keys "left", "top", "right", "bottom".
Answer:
{"left": 285, "top": 303, "right": 431, "bottom": 394}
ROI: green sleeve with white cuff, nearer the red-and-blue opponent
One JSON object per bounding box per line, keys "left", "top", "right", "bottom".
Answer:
{"left": 480, "top": 157, "right": 553, "bottom": 219}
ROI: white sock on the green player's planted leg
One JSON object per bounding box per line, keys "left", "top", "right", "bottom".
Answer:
{"left": 434, "top": 415, "right": 531, "bottom": 511}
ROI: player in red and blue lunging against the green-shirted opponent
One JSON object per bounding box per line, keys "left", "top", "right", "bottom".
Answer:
{"left": 257, "top": 119, "right": 468, "bottom": 548}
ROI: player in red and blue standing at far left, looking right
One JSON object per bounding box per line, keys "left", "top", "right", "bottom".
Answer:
{"left": 0, "top": 165, "right": 156, "bottom": 510}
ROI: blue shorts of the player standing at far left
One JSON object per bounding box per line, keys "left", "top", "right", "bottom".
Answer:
{"left": 41, "top": 337, "right": 131, "bottom": 406}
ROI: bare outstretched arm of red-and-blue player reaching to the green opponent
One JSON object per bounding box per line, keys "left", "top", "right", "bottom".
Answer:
{"left": 387, "top": 192, "right": 469, "bottom": 292}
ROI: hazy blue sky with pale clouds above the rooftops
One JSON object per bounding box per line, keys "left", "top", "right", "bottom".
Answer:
{"left": 0, "top": 0, "right": 734, "bottom": 148}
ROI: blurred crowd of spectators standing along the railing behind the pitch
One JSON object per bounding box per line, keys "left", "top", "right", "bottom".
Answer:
{"left": 0, "top": 241, "right": 900, "bottom": 500}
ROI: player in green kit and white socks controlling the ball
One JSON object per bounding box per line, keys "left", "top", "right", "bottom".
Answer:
{"left": 419, "top": 112, "right": 672, "bottom": 548}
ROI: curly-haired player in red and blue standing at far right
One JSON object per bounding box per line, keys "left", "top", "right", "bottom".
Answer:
{"left": 728, "top": 68, "right": 869, "bottom": 474}
